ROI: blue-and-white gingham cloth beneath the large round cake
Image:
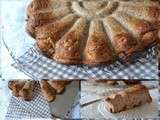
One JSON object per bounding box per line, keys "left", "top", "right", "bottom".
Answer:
{"left": 13, "top": 47, "right": 158, "bottom": 79}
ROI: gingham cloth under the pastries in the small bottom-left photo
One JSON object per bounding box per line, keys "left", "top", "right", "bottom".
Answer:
{"left": 5, "top": 83, "right": 51, "bottom": 120}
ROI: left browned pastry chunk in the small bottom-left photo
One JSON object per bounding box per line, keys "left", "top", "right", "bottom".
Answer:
{"left": 8, "top": 80, "right": 34, "bottom": 101}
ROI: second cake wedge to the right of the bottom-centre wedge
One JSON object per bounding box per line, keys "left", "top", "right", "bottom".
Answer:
{"left": 116, "top": 12, "right": 158, "bottom": 49}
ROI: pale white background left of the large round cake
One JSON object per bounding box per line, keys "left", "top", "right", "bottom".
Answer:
{"left": 0, "top": 0, "right": 34, "bottom": 79}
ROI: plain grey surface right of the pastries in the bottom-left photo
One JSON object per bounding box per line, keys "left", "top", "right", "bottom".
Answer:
{"left": 49, "top": 81, "right": 80, "bottom": 118}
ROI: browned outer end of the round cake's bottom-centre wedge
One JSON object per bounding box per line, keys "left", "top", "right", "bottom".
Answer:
{"left": 83, "top": 33, "right": 114, "bottom": 65}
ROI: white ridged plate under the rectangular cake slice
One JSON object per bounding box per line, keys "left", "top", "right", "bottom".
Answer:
{"left": 98, "top": 89, "right": 158, "bottom": 119}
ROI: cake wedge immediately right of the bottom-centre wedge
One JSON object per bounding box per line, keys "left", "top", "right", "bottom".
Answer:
{"left": 103, "top": 17, "right": 140, "bottom": 61}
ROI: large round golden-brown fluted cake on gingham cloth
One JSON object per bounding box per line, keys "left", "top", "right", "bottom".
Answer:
{"left": 26, "top": 0, "right": 160, "bottom": 66}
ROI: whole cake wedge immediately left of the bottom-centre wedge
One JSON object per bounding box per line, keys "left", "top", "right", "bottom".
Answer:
{"left": 54, "top": 18, "right": 88, "bottom": 64}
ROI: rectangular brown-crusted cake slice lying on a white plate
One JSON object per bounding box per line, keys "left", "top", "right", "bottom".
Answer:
{"left": 105, "top": 84, "right": 152, "bottom": 113}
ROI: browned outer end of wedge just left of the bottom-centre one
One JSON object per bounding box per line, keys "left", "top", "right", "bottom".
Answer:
{"left": 54, "top": 32, "right": 82, "bottom": 64}
